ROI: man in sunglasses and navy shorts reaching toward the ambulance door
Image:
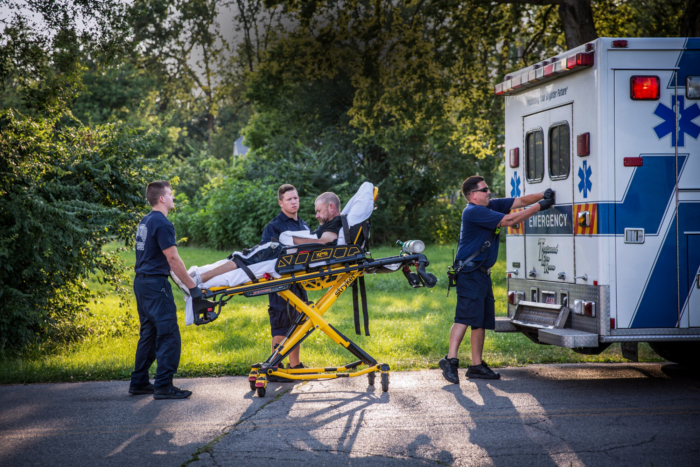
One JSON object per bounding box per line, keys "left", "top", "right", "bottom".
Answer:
{"left": 440, "top": 175, "right": 554, "bottom": 384}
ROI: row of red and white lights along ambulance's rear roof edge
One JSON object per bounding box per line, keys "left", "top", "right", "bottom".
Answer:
{"left": 494, "top": 50, "right": 595, "bottom": 96}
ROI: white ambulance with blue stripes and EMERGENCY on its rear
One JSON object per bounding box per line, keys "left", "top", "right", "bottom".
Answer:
{"left": 495, "top": 38, "right": 700, "bottom": 361}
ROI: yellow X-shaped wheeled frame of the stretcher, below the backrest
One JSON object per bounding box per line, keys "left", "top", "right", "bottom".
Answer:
{"left": 200, "top": 252, "right": 437, "bottom": 397}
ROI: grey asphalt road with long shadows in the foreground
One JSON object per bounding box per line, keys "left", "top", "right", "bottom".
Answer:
{"left": 0, "top": 363, "right": 700, "bottom": 467}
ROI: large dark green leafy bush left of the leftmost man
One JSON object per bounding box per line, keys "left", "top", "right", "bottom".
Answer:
{"left": 0, "top": 111, "right": 153, "bottom": 349}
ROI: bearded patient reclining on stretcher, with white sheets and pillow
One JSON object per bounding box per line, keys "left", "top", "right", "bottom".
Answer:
{"left": 171, "top": 182, "right": 374, "bottom": 324}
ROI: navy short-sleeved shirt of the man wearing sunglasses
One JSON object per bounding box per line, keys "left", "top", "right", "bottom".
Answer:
{"left": 455, "top": 198, "right": 515, "bottom": 268}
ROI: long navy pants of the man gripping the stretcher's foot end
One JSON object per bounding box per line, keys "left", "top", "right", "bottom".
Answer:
{"left": 131, "top": 274, "right": 181, "bottom": 389}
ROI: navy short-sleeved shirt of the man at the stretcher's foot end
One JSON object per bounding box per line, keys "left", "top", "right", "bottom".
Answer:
{"left": 134, "top": 211, "right": 177, "bottom": 276}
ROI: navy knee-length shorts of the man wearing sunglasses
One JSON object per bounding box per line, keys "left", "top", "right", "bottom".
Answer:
{"left": 455, "top": 270, "right": 496, "bottom": 329}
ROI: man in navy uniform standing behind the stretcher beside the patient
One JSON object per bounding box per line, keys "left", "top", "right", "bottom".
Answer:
{"left": 260, "top": 184, "right": 311, "bottom": 372}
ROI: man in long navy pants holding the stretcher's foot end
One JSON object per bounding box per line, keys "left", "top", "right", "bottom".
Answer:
{"left": 129, "top": 181, "right": 202, "bottom": 399}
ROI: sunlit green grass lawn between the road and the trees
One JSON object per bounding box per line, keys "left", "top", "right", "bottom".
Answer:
{"left": 0, "top": 244, "right": 661, "bottom": 383}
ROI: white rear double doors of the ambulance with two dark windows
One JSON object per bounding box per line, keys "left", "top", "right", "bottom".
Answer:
{"left": 523, "top": 104, "right": 575, "bottom": 290}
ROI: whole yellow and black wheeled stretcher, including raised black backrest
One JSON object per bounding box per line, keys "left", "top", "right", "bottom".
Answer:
{"left": 192, "top": 188, "right": 437, "bottom": 397}
